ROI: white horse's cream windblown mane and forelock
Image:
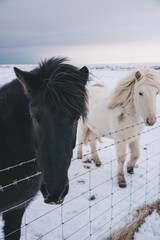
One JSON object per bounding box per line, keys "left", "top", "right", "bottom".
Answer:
{"left": 107, "top": 68, "right": 160, "bottom": 109}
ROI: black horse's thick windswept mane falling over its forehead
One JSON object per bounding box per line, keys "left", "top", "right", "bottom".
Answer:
{"left": 32, "top": 58, "right": 87, "bottom": 118}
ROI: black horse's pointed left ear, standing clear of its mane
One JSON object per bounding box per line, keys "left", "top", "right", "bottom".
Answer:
{"left": 14, "top": 67, "right": 38, "bottom": 96}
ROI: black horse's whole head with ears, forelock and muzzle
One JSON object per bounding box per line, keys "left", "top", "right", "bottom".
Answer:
{"left": 14, "top": 58, "right": 89, "bottom": 204}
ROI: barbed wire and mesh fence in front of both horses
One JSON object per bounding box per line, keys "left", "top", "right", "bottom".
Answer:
{"left": 0, "top": 119, "right": 160, "bottom": 240}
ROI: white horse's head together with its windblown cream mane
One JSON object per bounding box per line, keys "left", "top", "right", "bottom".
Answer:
{"left": 107, "top": 68, "right": 160, "bottom": 126}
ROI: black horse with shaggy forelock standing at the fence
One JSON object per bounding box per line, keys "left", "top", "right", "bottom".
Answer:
{"left": 0, "top": 58, "right": 89, "bottom": 240}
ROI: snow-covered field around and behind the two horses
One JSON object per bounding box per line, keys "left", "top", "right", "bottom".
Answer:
{"left": 0, "top": 64, "right": 160, "bottom": 240}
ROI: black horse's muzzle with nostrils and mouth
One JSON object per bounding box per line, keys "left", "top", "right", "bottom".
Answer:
{"left": 41, "top": 182, "right": 69, "bottom": 205}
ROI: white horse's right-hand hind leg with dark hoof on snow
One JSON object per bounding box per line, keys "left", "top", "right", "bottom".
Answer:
{"left": 90, "top": 132, "right": 102, "bottom": 167}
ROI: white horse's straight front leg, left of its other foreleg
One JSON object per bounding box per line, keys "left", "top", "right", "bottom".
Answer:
{"left": 116, "top": 143, "right": 127, "bottom": 188}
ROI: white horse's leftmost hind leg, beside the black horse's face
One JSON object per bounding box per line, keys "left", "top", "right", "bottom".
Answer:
{"left": 77, "top": 119, "right": 90, "bottom": 159}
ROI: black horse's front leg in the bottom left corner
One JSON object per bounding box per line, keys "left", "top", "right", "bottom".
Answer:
{"left": 3, "top": 208, "right": 25, "bottom": 240}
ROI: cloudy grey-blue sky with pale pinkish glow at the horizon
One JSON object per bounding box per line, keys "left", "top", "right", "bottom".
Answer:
{"left": 0, "top": 0, "right": 160, "bottom": 64}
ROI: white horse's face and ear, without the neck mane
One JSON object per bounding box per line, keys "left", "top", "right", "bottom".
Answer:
{"left": 134, "top": 70, "right": 160, "bottom": 126}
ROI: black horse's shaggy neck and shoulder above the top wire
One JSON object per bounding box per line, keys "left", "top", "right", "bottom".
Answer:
{"left": 0, "top": 80, "right": 35, "bottom": 166}
